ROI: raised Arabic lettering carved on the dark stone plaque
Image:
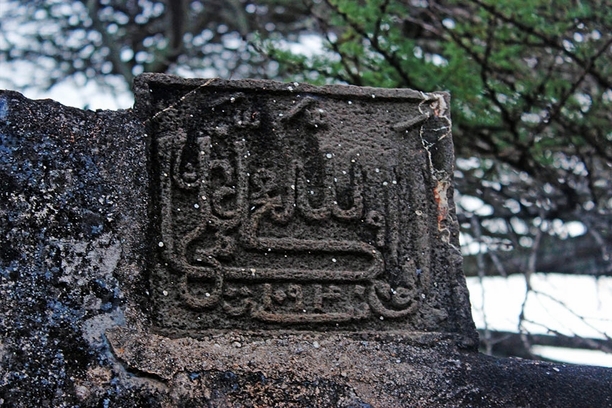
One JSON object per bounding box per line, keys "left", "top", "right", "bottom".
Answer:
{"left": 157, "top": 93, "right": 427, "bottom": 323}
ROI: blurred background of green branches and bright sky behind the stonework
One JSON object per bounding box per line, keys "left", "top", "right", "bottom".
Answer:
{"left": 0, "top": 0, "right": 612, "bottom": 366}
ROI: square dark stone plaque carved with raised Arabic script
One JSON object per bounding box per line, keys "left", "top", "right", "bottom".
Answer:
{"left": 137, "top": 75, "right": 469, "bottom": 335}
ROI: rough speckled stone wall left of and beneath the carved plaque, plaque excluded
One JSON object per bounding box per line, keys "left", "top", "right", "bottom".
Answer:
{"left": 0, "top": 77, "right": 612, "bottom": 407}
